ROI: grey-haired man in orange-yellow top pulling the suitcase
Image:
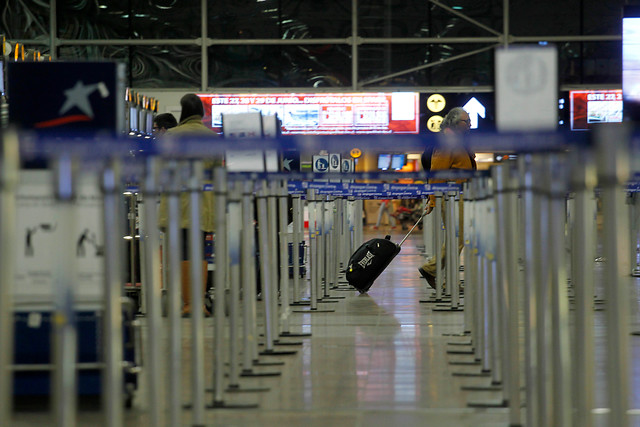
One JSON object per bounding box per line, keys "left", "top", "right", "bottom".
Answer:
{"left": 418, "top": 107, "right": 476, "bottom": 288}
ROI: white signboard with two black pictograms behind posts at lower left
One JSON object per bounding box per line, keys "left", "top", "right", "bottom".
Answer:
{"left": 13, "top": 171, "right": 104, "bottom": 303}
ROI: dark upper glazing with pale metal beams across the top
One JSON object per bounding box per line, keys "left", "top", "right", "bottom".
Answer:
{"left": 0, "top": 0, "right": 627, "bottom": 92}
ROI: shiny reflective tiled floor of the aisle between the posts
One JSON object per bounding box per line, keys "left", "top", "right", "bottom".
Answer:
{"left": 14, "top": 230, "right": 640, "bottom": 427}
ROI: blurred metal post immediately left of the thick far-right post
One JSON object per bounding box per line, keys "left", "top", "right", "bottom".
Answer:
{"left": 571, "top": 150, "right": 596, "bottom": 427}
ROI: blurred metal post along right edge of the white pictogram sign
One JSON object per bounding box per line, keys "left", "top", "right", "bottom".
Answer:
{"left": 102, "top": 160, "right": 124, "bottom": 427}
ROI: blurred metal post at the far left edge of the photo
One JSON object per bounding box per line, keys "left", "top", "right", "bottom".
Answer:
{"left": 0, "top": 131, "right": 20, "bottom": 423}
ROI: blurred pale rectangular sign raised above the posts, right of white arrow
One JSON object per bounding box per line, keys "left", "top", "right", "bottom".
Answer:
{"left": 495, "top": 46, "right": 558, "bottom": 132}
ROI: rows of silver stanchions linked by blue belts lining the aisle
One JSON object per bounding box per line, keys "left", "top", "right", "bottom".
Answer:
{"left": 0, "top": 127, "right": 640, "bottom": 427}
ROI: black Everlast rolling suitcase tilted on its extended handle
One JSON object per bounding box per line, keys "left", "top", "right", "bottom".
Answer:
{"left": 346, "top": 211, "right": 424, "bottom": 294}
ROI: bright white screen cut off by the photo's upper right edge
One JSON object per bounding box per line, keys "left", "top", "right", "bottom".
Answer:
{"left": 622, "top": 6, "right": 640, "bottom": 121}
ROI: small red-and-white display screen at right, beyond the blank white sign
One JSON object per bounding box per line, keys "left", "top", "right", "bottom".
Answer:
{"left": 569, "top": 89, "right": 622, "bottom": 130}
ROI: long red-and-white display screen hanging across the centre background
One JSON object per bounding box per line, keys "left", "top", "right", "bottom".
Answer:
{"left": 198, "top": 92, "right": 419, "bottom": 135}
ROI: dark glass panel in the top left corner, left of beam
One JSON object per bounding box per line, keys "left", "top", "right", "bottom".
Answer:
{"left": 0, "top": 0, "right": 49, "bottom": 39}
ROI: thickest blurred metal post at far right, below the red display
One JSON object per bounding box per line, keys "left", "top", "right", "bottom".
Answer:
{"left": 596, "top": 126, "right": 631, "bottom": 427}
